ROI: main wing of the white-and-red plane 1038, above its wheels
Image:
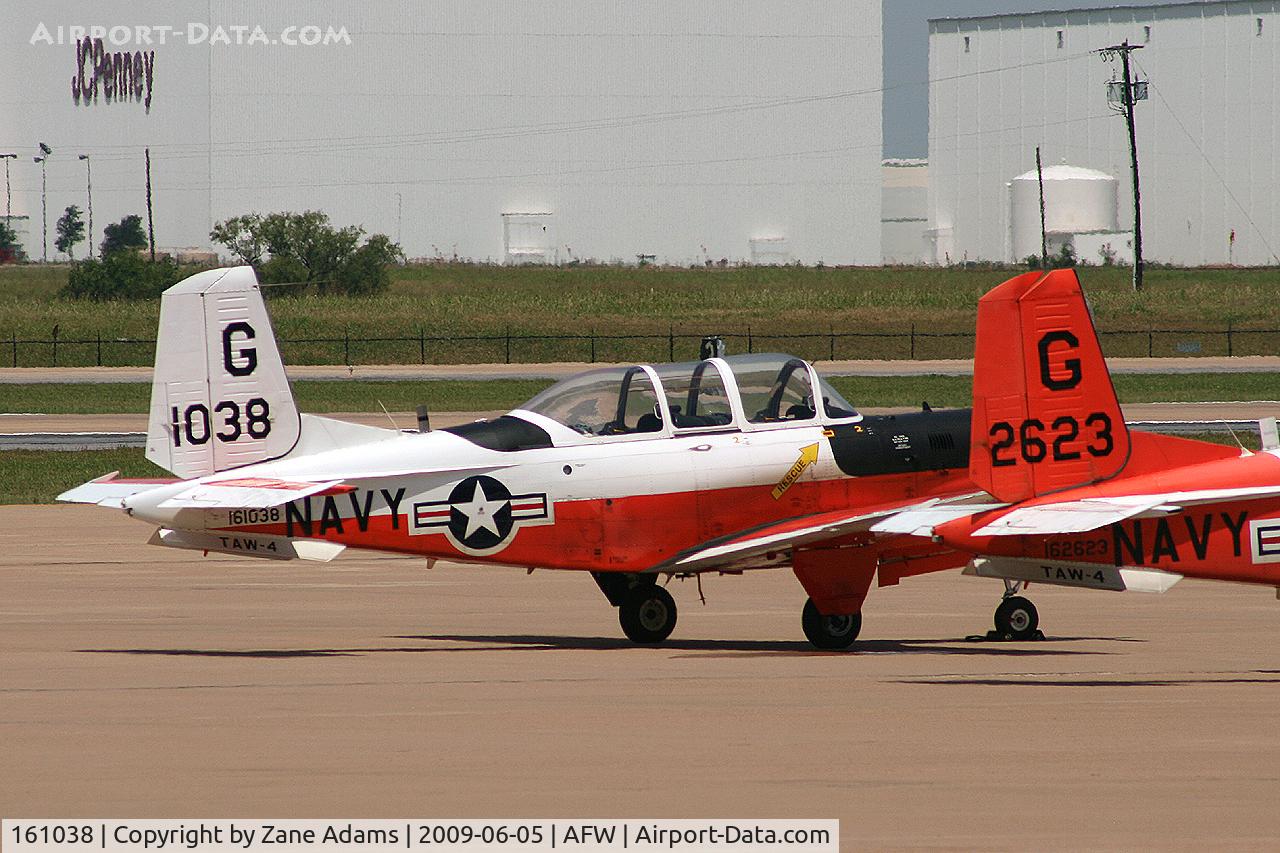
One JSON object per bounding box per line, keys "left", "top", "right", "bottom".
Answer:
{"left": 648, "top": 494, "right": 977, "bottom": 573}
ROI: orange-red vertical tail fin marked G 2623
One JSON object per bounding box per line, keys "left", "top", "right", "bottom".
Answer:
{"left": 969, "top": 269, "right": 1130, "bottom": 502}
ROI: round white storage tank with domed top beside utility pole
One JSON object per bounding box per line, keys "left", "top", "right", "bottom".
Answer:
{"left": 1009, "top": 165, "right": 1117, "bottom": 261}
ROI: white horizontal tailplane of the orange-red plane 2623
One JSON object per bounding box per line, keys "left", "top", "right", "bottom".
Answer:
{"left": 973, "top": 485, "right": 1280, "bottom": 537}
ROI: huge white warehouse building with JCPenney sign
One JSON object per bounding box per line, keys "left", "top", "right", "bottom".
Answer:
{"left": 0, "top": 0, "right": 882, "bottom": 264}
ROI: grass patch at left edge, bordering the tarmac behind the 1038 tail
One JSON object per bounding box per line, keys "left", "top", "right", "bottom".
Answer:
{"left": 0, "top": 448, "right": 172, "bottom": 503}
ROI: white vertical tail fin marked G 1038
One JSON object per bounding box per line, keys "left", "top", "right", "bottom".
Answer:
{"left": 146, "top": 266, "right": 301, "bottom": 478}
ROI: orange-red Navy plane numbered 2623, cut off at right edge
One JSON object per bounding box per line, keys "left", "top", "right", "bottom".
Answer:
{"left": 873, "top": 270, "right": 1280, "bottom": 639}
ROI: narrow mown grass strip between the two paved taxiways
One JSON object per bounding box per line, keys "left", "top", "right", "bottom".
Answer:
{"left": 0, "top": 373, "right": 1280, "bottom": 415}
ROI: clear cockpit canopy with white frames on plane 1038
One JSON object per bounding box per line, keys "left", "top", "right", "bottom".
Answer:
{"left": 518, "top": 353, "right": 859, "bottom": 437}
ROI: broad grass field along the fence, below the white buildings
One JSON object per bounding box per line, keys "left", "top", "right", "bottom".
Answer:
{"left": 0, "top": 264, "right": 1280, "bottom": 365}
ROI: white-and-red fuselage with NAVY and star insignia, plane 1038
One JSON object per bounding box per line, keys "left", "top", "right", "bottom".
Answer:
{"left": 128, "top": 411, "right": 973, "bottom": 573}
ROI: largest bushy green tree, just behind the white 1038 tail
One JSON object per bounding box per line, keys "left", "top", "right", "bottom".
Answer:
{"left": 209, "top": 210, "right": 404, "bottom": 293}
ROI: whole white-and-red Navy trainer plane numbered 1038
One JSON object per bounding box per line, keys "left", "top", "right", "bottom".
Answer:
{"left": 60, "top": 266, "right": 983, "bottom": 648}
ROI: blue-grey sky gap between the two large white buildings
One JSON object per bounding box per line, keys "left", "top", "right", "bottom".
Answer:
{"left": 884, "top": 0, "right": 1167, "bottom": 158}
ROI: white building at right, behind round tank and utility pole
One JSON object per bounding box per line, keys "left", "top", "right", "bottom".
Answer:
{"left": 928, "top": 0, "right": 1280, "bottom": 265}
